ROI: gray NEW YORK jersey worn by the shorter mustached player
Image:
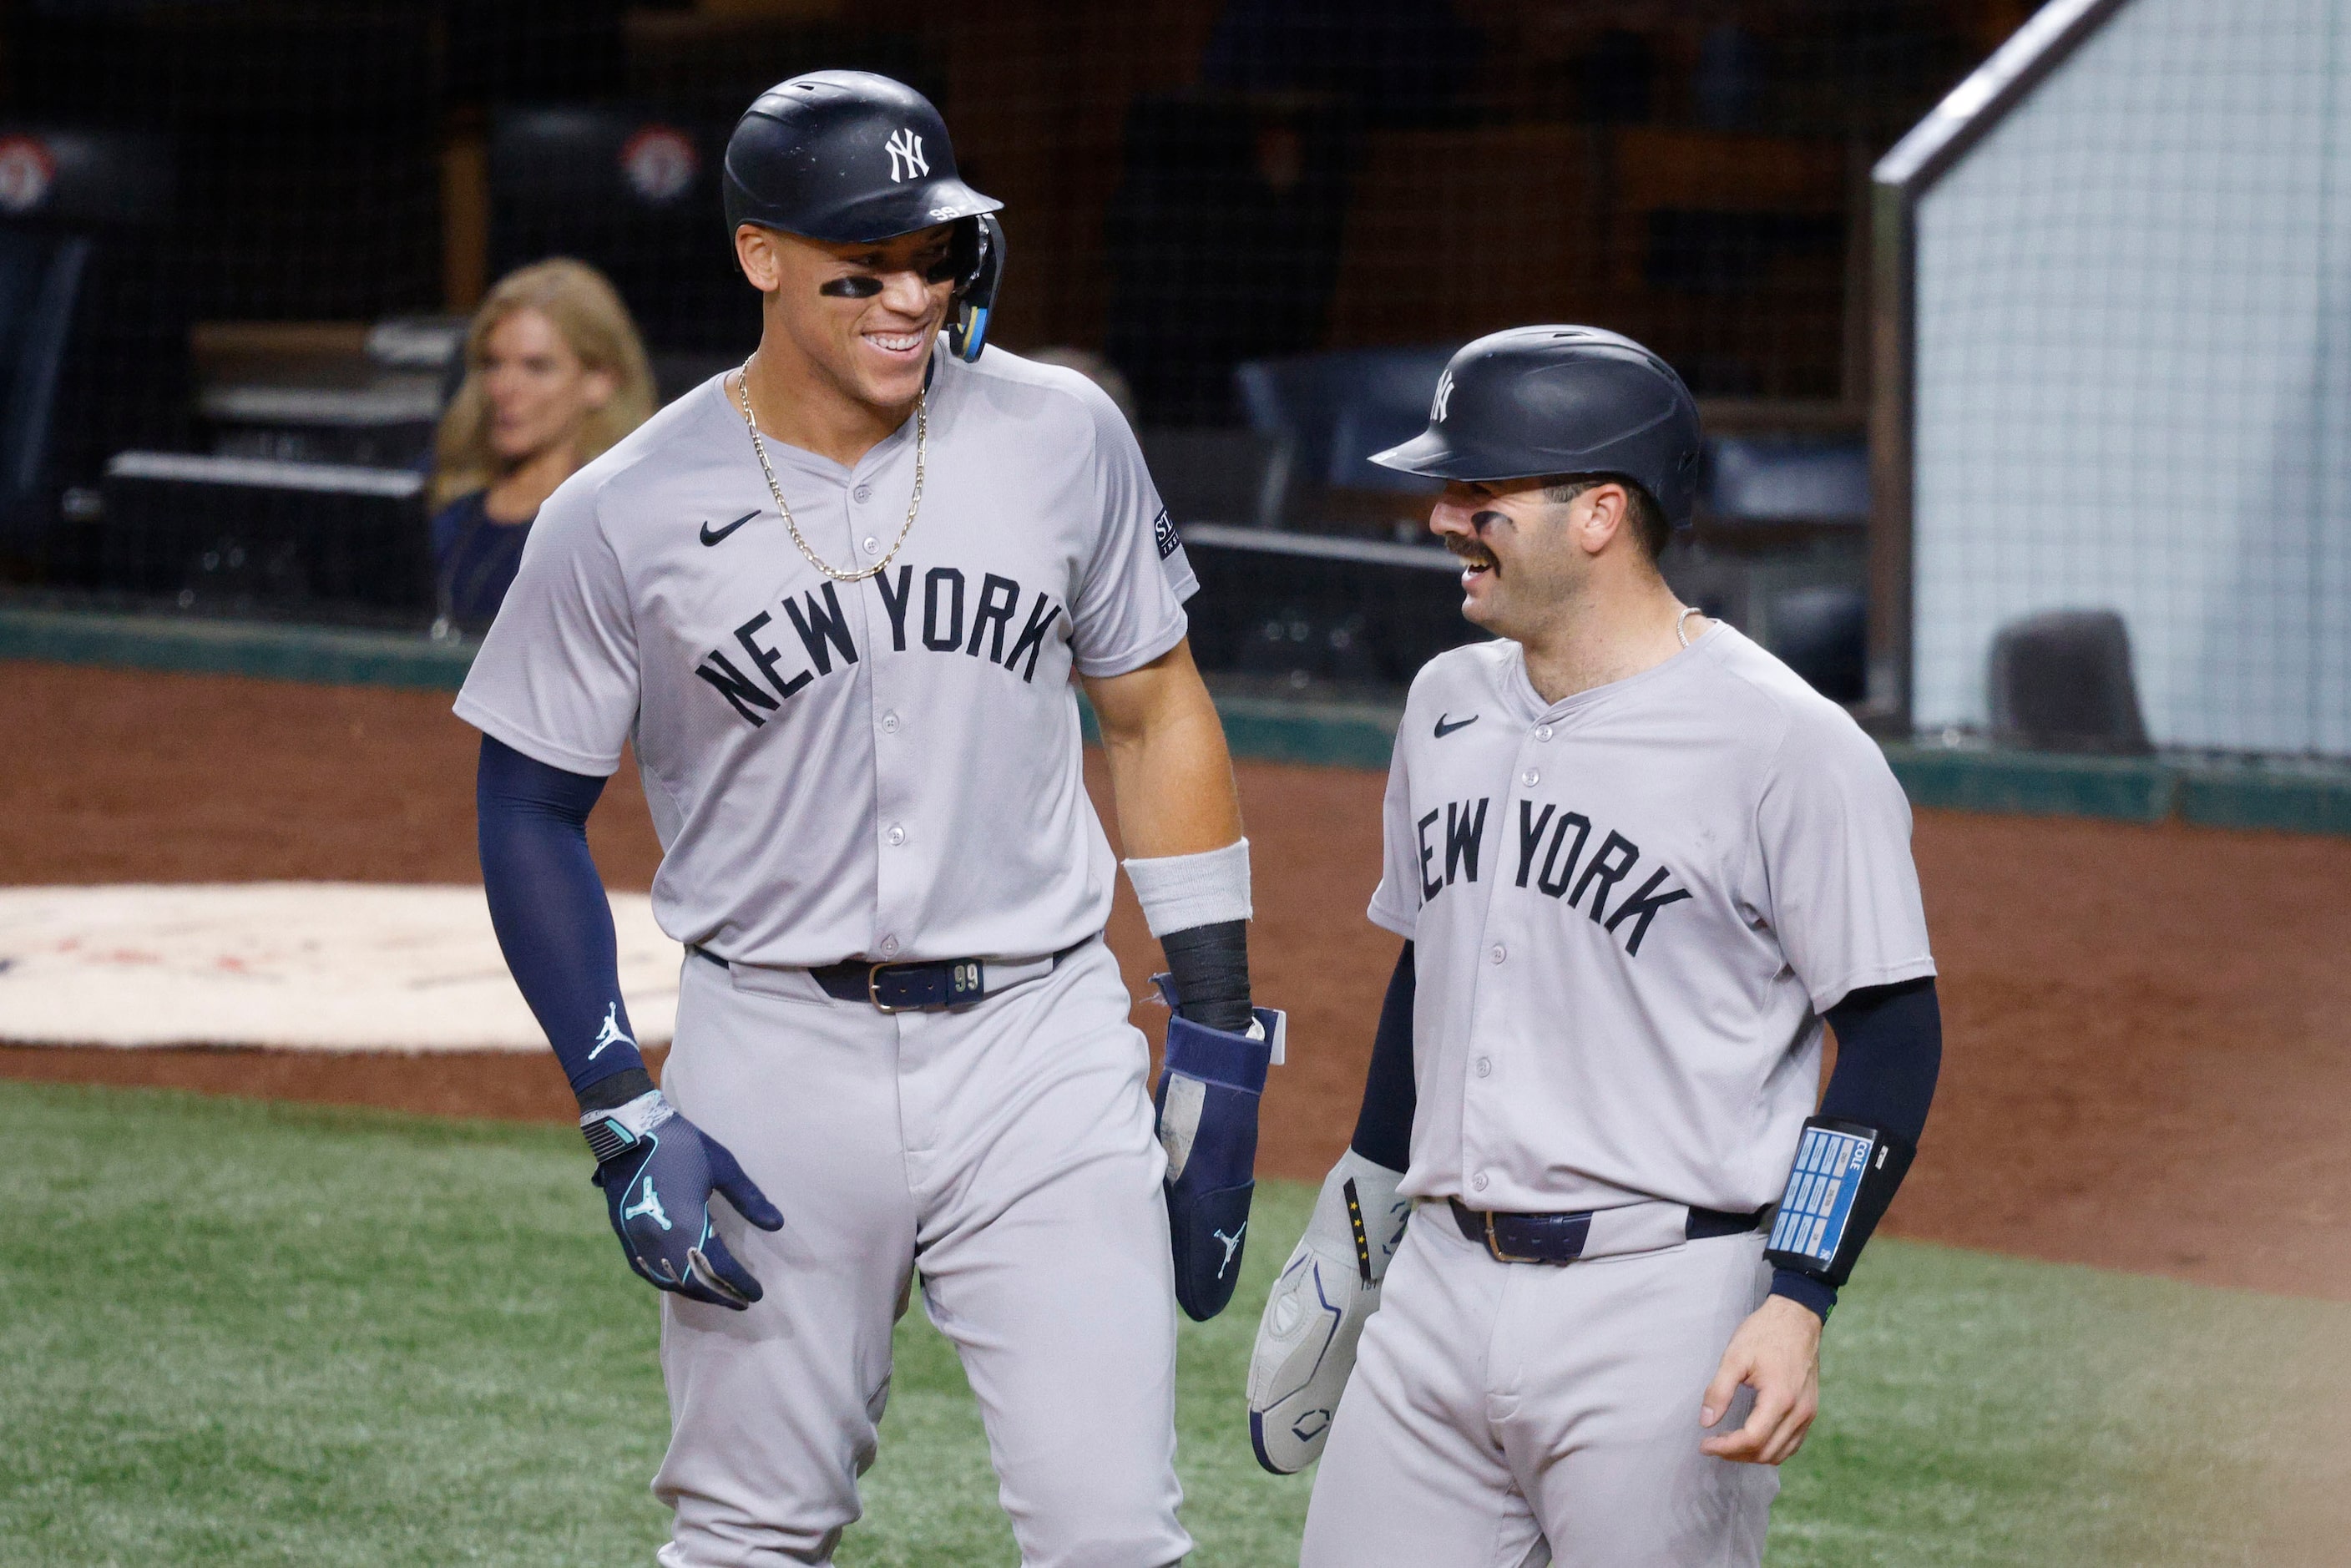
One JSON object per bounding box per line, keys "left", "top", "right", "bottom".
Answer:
{"left": 1371, "top": 625, "right": 1935, "bottom": 1211}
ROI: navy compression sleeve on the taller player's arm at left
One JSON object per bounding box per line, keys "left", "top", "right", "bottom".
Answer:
{"left": 473, "top": 736, "right": 654, "bottom": 1110}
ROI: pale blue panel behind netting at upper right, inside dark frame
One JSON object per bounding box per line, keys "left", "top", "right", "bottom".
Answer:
{"left": 1914, "top": 0, "right": 2351, "bottom": 757}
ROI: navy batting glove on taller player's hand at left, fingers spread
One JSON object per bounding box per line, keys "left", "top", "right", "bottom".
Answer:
{"left": 581, "top": 1089, "right": 783, "bottom": 1312}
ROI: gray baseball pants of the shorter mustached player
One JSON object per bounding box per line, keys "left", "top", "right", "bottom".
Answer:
{"left": 1300, "top": 1204, "right": 1780, "bottom": 1568}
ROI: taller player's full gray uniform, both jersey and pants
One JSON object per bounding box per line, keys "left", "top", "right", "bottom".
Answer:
{"left": 458, "top": 351, "right": 1192, "bottom": 1565}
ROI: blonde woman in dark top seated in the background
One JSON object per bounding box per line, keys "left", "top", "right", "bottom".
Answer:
{"left": 432, "top": 256, "right": 654, "bottom": 632}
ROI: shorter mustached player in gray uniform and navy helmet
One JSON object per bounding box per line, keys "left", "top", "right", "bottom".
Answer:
{"left": 1248, "top": 326, "right": 1939, "bottom": 1568}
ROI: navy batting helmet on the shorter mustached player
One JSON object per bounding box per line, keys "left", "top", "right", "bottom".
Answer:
{"left": 1371, "top": 326, "right": 1700, "bottom": 529}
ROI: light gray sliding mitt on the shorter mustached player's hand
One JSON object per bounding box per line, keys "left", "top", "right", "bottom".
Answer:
{"left": 1248, "top": 1150, "right": 1413, "bottom": 1476}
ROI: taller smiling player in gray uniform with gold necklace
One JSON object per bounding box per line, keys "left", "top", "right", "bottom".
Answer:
{"left": 456, "top": 70, "right": 1282, "bottom": 1568}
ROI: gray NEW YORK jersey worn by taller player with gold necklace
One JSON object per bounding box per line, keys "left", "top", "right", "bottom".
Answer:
{"left": 456, "top": 351, "right": 1195, "bottom": 966}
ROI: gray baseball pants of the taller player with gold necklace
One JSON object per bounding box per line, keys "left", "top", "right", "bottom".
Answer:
{"left": 654, "top": 940, "right": 1192, "bottom": 1568}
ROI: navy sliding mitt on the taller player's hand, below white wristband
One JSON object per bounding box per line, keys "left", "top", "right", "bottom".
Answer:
{"left": 1152, "top": 983, "right": 1284, "bottom": 1323}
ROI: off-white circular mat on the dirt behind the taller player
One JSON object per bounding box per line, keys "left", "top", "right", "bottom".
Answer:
{"left": 0, "top": 882, "right": 682, "bottom": 1051}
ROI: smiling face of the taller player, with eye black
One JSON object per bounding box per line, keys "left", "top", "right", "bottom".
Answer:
{"left": 736, "top": 223, "right": 954, "bottom": 409}
